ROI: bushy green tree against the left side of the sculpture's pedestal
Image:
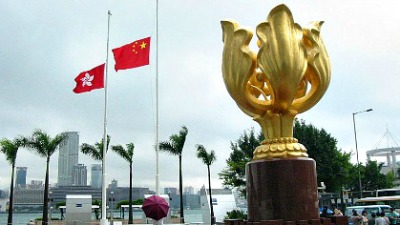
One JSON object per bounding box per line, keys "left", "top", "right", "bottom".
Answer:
{"left": 218, "top": 128, "right": 263, "bottom": 196}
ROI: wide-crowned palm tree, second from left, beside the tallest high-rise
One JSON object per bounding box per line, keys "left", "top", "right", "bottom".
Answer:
{"left": 25, "top": 129, "right": 68, "bottom": 225}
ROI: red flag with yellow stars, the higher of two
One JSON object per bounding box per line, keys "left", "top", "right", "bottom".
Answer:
{"left": 112, "top": 37, "right": 150, "bottom": 71}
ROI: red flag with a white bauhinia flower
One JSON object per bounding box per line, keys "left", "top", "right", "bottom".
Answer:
{"left": 73, "top": 63, "right": 105, "bottom": 94}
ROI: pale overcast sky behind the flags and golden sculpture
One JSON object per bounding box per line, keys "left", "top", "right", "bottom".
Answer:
{"left": 0, "top": 0, "right": 400, "bottom": 193}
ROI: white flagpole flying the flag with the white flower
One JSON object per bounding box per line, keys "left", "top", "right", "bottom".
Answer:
{"left": 100, "top": 10, "right": 111, "bottom": 225}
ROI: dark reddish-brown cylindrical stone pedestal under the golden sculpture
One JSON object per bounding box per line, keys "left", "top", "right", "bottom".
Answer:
{"left": 246, "top": 158, "right": 319, "bottom": 221}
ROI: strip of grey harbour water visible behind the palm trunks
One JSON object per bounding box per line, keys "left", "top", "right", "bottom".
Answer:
{"left": 0, "top": 210, "right": 202, "bottom": 225}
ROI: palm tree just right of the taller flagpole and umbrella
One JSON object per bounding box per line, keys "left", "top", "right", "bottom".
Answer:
{"left": 160, "top": 126, "right": 188, "bottom": 223}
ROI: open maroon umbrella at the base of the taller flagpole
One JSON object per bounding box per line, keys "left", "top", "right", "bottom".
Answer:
{"left": 142, "top": 195, "right": 169, "bottom": 220}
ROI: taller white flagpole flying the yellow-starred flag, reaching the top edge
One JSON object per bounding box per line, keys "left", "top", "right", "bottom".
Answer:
{"left": 156, "top": 0, "right": 160, "bottom": 195}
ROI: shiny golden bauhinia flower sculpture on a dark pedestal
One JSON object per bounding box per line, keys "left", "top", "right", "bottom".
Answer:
{"left": 221, "top": 5, "right": 331, "bottom": 160}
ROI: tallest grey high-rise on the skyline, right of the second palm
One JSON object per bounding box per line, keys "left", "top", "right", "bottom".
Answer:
{"left": 57, "top": 131, "right": 79, "bottom": 186}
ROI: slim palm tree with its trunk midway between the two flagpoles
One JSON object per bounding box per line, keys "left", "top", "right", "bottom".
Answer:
{"left": 111, "top": 143, "right": 135, "bottom": 224}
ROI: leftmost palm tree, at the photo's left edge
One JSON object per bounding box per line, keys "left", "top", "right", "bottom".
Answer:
{"left": 0, "top": 138, "right": 25, "bottom": 225}
